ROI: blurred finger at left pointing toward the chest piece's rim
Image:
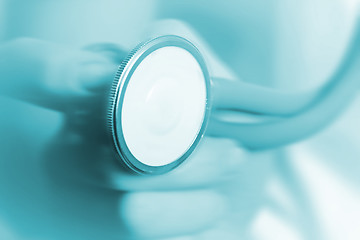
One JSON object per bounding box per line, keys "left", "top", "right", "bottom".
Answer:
{"left": 0, "top": 38, "right": 121, "bottom": 111}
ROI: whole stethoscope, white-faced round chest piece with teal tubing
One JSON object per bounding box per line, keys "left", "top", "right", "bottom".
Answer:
{"left": 107, "top": 19, "right": 360, "bottom": 174}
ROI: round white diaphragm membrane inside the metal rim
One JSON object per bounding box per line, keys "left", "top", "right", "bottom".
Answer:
{"left": 121, "top": 46, "right": 207, "bottom": 166}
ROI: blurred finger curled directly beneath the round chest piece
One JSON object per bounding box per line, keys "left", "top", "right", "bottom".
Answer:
{"left": 99, "top": 137, "right": 247, "bottom": 191}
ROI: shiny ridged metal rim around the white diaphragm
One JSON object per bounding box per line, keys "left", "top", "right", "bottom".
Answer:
{"left": 107, "top": 35, "right": 211, "bottom": 174}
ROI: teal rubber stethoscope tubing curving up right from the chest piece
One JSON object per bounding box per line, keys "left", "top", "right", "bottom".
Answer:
{"left": 207, "top": 15, "right": 360, "bottom": 150}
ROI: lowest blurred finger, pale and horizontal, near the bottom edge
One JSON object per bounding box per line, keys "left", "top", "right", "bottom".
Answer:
{"left": 119, "top": 190, "right": 226, "bottom": 239}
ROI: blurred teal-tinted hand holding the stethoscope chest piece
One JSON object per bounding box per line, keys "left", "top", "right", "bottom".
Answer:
{"left": 0, "top": 39, "right": 250, "bottom": 239}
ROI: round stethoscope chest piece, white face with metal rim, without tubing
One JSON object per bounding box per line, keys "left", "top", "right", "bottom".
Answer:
{"left": 108, "top": 35, "right": 210, "bottom": 174}
